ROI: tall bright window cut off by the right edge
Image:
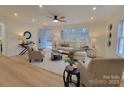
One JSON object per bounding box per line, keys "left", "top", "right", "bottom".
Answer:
{"left": 117, "top": 20, "right": 124, "bottom": 57}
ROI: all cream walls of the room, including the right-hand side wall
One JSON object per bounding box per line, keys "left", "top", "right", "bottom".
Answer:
{"left": 0, "top": 14, "right": 123, "bottom": 57}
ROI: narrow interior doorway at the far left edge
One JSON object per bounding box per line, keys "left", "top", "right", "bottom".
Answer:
{"left": 0, "top": 23, "right": 6, "bottom": 55}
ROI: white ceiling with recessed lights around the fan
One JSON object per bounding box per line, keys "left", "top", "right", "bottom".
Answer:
{"left": 0, "top": 5, "right": 124, "bottom": 25}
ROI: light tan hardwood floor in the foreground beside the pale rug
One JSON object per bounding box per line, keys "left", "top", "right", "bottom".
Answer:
{"left": 0, "top": 55, "right": 63, "bottom": 87}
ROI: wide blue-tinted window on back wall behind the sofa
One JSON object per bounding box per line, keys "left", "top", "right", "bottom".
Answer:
{"left": 61, "top": 28, "right": 88, "bottom": 43}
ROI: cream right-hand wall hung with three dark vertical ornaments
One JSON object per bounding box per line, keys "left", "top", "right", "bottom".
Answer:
{"left": 106, "top": 9, "right": 124, "bottom": 58}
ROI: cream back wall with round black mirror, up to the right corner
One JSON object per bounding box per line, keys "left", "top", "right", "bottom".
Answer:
{"left": 0, "top": 14, "right": 106, "bottom": 56}
